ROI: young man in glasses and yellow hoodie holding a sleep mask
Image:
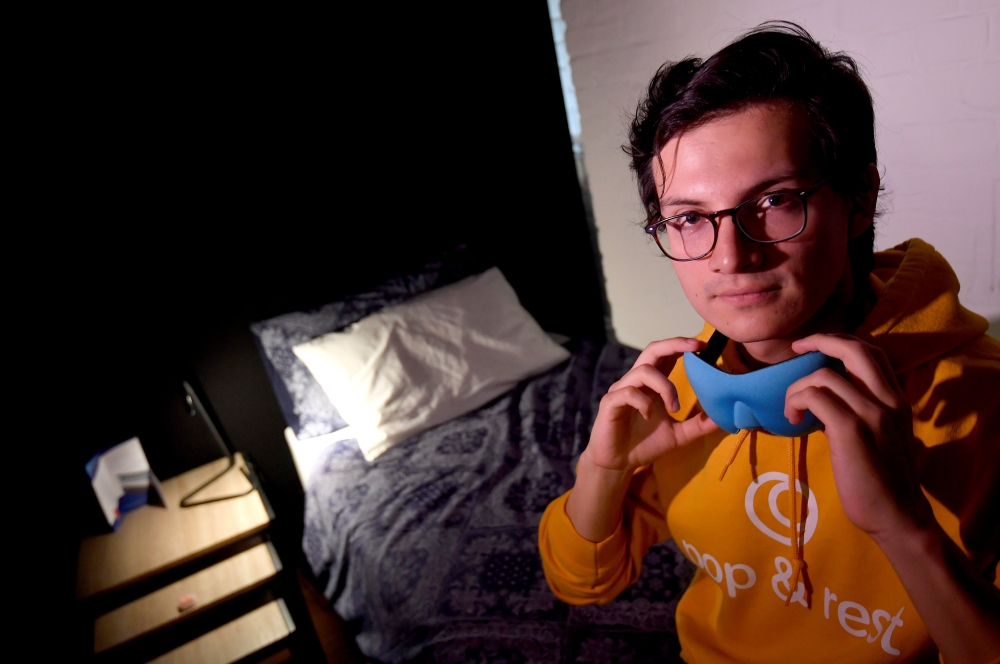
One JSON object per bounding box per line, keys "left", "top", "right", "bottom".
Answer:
{"left": 539, "top": 24, "right": 1000, "bottom": 664}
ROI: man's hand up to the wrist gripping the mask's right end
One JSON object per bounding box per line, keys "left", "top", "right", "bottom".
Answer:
{"left": 785, "top": 334, "right": 933, "bottom": 540}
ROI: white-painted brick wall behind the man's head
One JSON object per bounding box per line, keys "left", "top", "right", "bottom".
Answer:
{"left": 561, "top": 0, "right": 1000, "bottom": 347}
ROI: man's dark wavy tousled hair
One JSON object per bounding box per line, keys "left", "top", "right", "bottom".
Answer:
{"left": 622, "top": 21, "right": 878, "bottom": 320}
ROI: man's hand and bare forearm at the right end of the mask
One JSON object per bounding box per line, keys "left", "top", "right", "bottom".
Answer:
{"left": 785, "top": 334, "right": 1000, "bottom": 664}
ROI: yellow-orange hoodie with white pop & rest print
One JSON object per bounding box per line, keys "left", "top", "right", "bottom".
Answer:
{"left": 539, "top": 240, "right": 1000, "bottom": 664}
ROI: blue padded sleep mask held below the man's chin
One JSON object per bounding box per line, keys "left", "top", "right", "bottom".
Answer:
{"left": 684, "top": 331, "right": 843, "bottom": 437}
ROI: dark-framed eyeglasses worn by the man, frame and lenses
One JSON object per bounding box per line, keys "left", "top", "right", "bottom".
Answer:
{"left": 643, "top": 180, "right": 826, "bottom": 261}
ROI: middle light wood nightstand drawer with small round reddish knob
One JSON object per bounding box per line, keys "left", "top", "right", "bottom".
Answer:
{"left": 94, "top": 542, "right": 281, "bottom": 653}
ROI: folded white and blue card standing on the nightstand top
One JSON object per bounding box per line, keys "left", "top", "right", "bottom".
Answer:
{"left": 87, "top": 438, "right": 164, "bottom": 530}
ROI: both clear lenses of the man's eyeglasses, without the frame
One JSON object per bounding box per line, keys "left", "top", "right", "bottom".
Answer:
{"left": 656, "top": 192, "right": 806, "bottom": 259}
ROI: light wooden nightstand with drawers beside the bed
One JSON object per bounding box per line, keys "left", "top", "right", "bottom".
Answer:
{"left": 76, "top": 454, "right": 313, "bottom": 664}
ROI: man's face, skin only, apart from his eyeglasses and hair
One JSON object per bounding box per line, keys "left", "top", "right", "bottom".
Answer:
{"left": 653, "top": 102, "right": 863, "bottom": 343}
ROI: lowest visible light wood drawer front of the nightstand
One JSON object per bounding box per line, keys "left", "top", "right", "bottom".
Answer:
{"left": 150, "top": 598, "right": 295, "bottom": 664}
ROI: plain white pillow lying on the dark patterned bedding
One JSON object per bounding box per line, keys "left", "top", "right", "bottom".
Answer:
{"left": 292, "top": 267, "right": 569, "bottom": 461}
